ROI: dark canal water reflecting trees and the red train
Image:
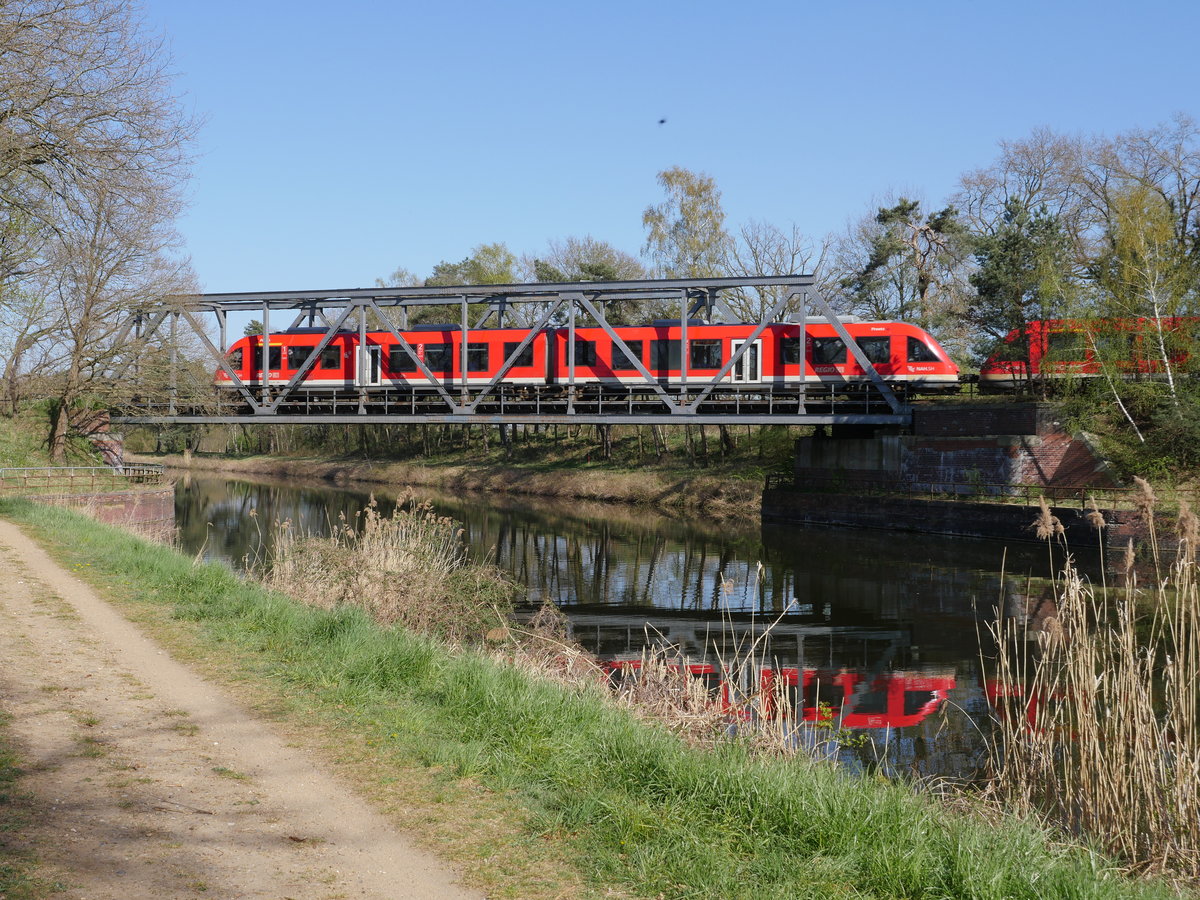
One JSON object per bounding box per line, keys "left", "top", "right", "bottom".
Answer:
{"left": 175, "top": 475, "right": 1088, "bottom": 778}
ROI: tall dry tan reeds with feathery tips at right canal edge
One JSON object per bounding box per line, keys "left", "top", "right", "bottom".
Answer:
{"left": 994, "top": 482, "right": 1200, "bottom": 878}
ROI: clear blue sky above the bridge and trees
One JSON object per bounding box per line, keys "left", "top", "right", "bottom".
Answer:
{"left": 144, "top": 0, "right": 1200, "bottom": 292}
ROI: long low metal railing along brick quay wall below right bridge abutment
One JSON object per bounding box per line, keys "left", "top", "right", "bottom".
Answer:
{"left": 766, "top": 472, "right": 1140, "bottom": 509}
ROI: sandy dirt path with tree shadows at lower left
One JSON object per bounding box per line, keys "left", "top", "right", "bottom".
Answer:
{"left": 0, "top": 521, "right": 481, "bottom": 900}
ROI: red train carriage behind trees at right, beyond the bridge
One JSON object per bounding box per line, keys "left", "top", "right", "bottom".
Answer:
{"left": 979, "top": 317, "right": 1200, "bottom": 391}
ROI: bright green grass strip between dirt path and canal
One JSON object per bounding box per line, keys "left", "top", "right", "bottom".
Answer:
{"left": 0, "top": 502, "right": 1171, "bottom": 899}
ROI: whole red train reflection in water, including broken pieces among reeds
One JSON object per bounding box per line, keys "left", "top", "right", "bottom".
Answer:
{"left": 604, "top": 660, "right": 955, "bottom": 728}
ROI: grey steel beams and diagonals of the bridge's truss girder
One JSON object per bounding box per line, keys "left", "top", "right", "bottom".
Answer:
{"left": 113, "top": 275, "right": 911, "bottom": 425}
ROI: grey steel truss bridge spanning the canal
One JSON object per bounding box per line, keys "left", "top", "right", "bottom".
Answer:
{"left": 112, "top": 275, "right": 912, "bottom": 425}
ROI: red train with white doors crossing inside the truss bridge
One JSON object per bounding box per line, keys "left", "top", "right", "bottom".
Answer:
{"left": 216, "top": 320, "right": 959, "bottom": 392}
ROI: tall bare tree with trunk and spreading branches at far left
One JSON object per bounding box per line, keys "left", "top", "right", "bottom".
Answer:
{"left": 0, "top": 0, "right": 198, "bottom": 451}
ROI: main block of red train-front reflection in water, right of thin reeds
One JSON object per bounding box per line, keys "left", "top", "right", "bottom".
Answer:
{"left": 762, "top": 667, "right": 955, "bottom": 728}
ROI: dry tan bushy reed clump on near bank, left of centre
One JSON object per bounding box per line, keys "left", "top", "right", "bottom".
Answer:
{"left": 260, "top": 499, "right": 515, "bottom": 643}
